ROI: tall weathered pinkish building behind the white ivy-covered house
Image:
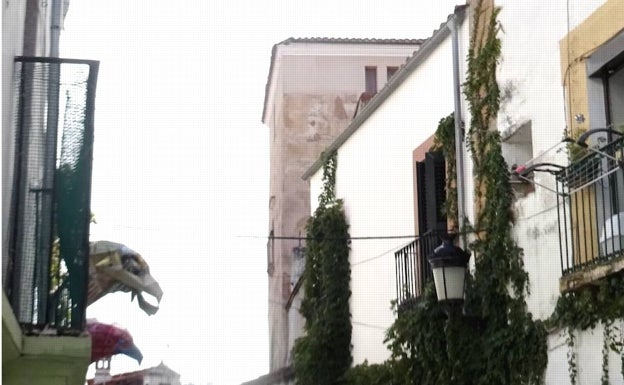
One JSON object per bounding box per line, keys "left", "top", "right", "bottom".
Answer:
{"left": 262, "top": 38, "right": 422, "bottom": 372}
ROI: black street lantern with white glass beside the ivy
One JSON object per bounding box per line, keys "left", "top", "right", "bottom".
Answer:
{"left": 428, "top": 238, "right": 470, "bottom": 304}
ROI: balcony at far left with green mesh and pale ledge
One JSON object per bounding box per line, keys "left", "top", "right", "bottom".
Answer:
{"left": 2, "top": 57, "right": 98, "bottom": 385}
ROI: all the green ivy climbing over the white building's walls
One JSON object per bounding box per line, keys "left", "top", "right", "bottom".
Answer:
{"left": 294, "top": 0, "right": 624, "bottom": 385}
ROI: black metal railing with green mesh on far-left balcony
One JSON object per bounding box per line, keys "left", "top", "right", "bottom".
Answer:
{"left": 3, "top": 57, "right": 98, "bottom": 333}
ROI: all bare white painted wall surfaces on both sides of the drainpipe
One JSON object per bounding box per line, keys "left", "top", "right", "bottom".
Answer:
{"left": 310, "top": 0, "right": 624, "bottom": 384}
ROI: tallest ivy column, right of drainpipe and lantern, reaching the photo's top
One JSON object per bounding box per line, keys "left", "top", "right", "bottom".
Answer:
{"left": 464, "top": 4, "right": 548, "bottom": 384}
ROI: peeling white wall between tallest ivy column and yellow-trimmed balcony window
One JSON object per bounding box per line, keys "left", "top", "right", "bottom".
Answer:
{"left": 465, "top": 0, "right": 623, "bottom": 384}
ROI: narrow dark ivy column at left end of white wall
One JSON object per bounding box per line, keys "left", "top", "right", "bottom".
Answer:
{"left": 293, "top": 154, "right": 352, "bottom": 385}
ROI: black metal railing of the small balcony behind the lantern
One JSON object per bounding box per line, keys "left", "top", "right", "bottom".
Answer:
{"left": 394, "top": 231, "right": 441, "bottom": 311}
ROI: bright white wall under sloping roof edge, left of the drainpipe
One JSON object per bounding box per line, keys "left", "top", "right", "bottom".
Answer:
{"left": 310, "top": 21, "right": 469, "bottom": 364}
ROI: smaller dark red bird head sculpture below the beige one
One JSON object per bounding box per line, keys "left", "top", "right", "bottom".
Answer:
{"left": 87, "top": 319, "right": 143, "bottom": 365}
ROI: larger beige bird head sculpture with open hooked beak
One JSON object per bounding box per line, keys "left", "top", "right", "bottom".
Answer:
{"left": 87, "top": 241, "right": 163, "bottom": 315}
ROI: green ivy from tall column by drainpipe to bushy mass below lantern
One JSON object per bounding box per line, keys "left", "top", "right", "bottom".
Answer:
{"left": 342, "top": 2, "right": 548, "bottom": 385}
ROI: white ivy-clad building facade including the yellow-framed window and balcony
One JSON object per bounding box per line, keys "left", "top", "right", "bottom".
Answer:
{"left": 304, "top": 0, "right": 624, "bottom": 384}
